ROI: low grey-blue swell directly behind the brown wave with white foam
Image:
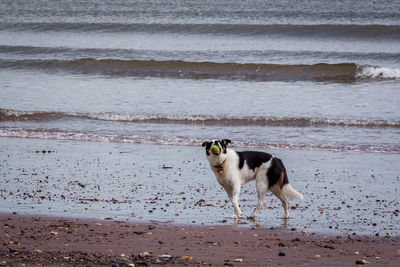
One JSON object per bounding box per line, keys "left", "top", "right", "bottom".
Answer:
{"left": 0, "top": 45, "right": 400, "bottom": 66}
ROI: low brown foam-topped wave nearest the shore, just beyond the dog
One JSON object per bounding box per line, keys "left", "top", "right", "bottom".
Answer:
{"left": 0, "top": 109, "right": 400, "bottom": 128}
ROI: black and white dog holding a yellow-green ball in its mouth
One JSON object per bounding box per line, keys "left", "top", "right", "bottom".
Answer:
{"left": 203, "top": 139, "right": 303, "bottom": 219}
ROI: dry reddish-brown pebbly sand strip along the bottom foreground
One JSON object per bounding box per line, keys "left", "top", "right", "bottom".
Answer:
{"left": 0, "top": 213, "right": 400, "bottom": 266}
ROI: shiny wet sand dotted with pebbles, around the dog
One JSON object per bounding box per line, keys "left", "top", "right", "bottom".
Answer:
{"left": 0, "top": 138, "right": 400, "bottom": 236}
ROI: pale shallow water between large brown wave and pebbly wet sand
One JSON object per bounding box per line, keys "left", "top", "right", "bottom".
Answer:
{"left": 0, "top": 71, "right": 400, "bottom": 153}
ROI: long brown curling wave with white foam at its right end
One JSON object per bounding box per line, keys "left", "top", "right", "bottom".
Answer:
{"left": 0, "top": 58, "right": 400, "bottom": 82}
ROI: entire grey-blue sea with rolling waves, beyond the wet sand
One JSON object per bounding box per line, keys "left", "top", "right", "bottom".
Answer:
{"left": 0, "top": 0, "right": 400, "bottom": 154}
